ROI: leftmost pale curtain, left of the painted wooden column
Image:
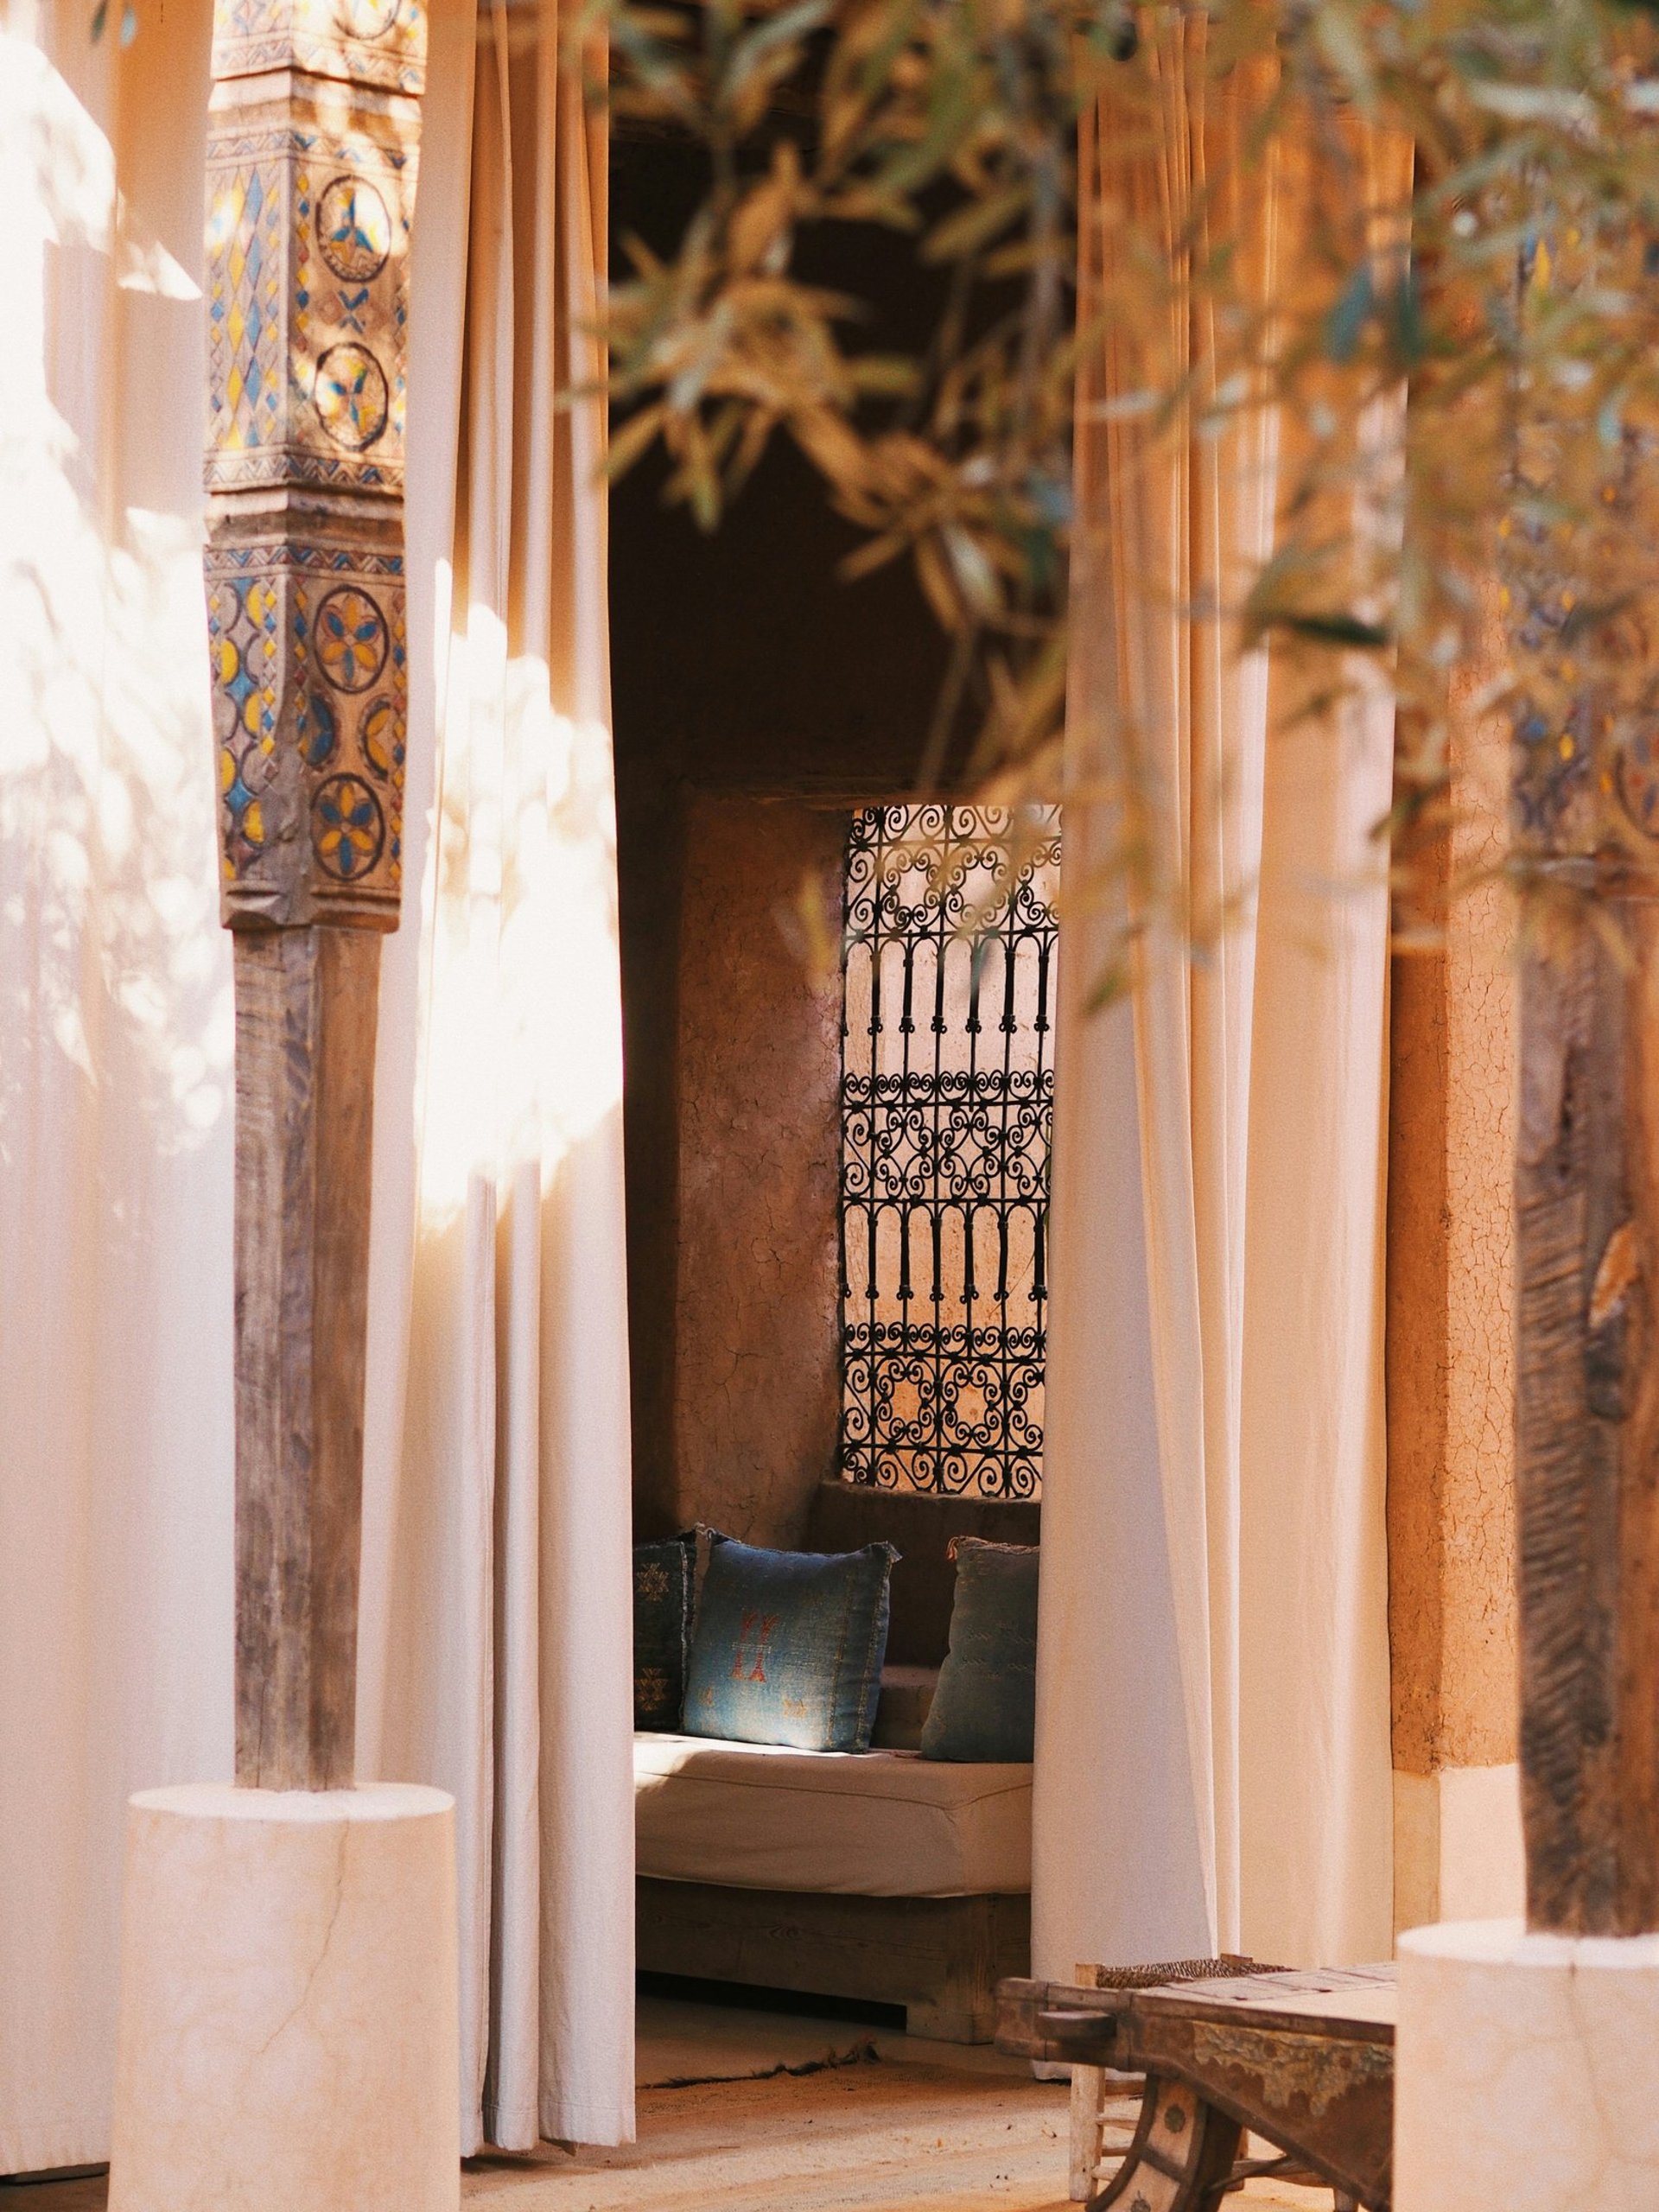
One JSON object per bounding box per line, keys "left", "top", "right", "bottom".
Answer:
{"left": 0, "top": 0, "right": 234, "bottom": 2172}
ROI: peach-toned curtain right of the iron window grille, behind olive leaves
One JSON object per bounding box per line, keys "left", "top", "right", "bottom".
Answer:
{"left": 1033, "top": 26, "right": 1409, "bottom": 1974}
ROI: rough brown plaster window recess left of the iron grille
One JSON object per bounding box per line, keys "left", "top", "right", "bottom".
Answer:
{"left": 672, "top": 794, "right": 847, "bottom": 1546}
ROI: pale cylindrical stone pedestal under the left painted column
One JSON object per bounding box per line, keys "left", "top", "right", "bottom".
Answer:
{"left": 108, "top": 1785, "right": 460, "bottom": 2212}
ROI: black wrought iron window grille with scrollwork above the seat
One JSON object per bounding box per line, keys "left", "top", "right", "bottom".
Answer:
{"left": 841, "top": 803, "right": 1059, "bottom": 1497}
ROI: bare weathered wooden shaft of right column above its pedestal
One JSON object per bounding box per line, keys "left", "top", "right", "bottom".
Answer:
{"left": 1516, "top": 889, "right": 1659, "bottom": 1936}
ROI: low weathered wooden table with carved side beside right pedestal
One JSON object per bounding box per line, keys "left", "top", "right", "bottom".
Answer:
{"left": 998, "top": 1967, "right": 1394, "bottom": 2212}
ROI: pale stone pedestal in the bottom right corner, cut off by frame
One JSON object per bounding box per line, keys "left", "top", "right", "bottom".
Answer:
{"left": 1394, "top": 1920, "right": 1659, "bottom": 2212}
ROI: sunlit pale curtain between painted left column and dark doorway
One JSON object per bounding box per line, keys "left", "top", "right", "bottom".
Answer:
{"left": 359, "top": 0, "right": 632, "bottom": 2150}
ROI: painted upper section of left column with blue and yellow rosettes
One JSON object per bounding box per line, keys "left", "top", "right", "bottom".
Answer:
{"left": 204, "top": 0, "right": 425, "bottom": 929}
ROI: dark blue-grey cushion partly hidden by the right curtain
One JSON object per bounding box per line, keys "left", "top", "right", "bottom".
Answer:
{"left": 923, "top": 1535, "right": 1039, "bottom": 1761}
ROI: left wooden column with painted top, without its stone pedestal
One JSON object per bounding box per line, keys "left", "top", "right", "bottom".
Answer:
{"left": 206, "top": 0, "right": 425, "bottom": 1789}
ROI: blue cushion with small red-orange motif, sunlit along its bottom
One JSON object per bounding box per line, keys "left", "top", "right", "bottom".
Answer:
{"left": 686, "top": 1535, "right": 898, "bottom": 1752}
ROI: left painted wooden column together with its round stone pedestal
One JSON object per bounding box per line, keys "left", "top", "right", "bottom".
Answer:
{"left": 108, "top": 35, "right": 460, "bottom": 2212}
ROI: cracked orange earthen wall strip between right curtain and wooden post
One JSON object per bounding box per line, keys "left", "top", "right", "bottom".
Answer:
{"left": 1387, "top": 677, "right": 1517, "bottom": 1774}
